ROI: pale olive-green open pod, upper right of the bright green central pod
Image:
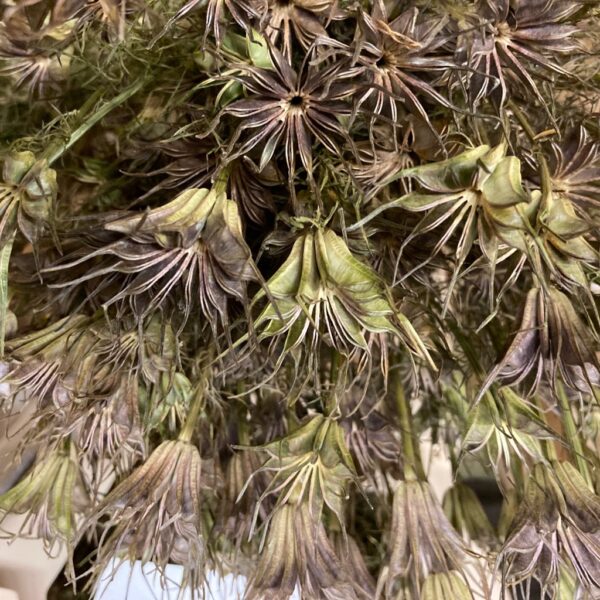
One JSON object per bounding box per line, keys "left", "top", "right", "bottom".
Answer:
{"left": 347, "top": 145, "right": 529, "bottom": 305}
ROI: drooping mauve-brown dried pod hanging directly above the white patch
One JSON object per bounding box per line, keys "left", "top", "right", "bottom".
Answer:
{"left": 88, "top": 440, "right": 214, "bottom": 589}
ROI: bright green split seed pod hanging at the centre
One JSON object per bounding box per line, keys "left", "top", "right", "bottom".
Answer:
{"left": 253, "top": 227, "right": 435, "bottom": 368}
